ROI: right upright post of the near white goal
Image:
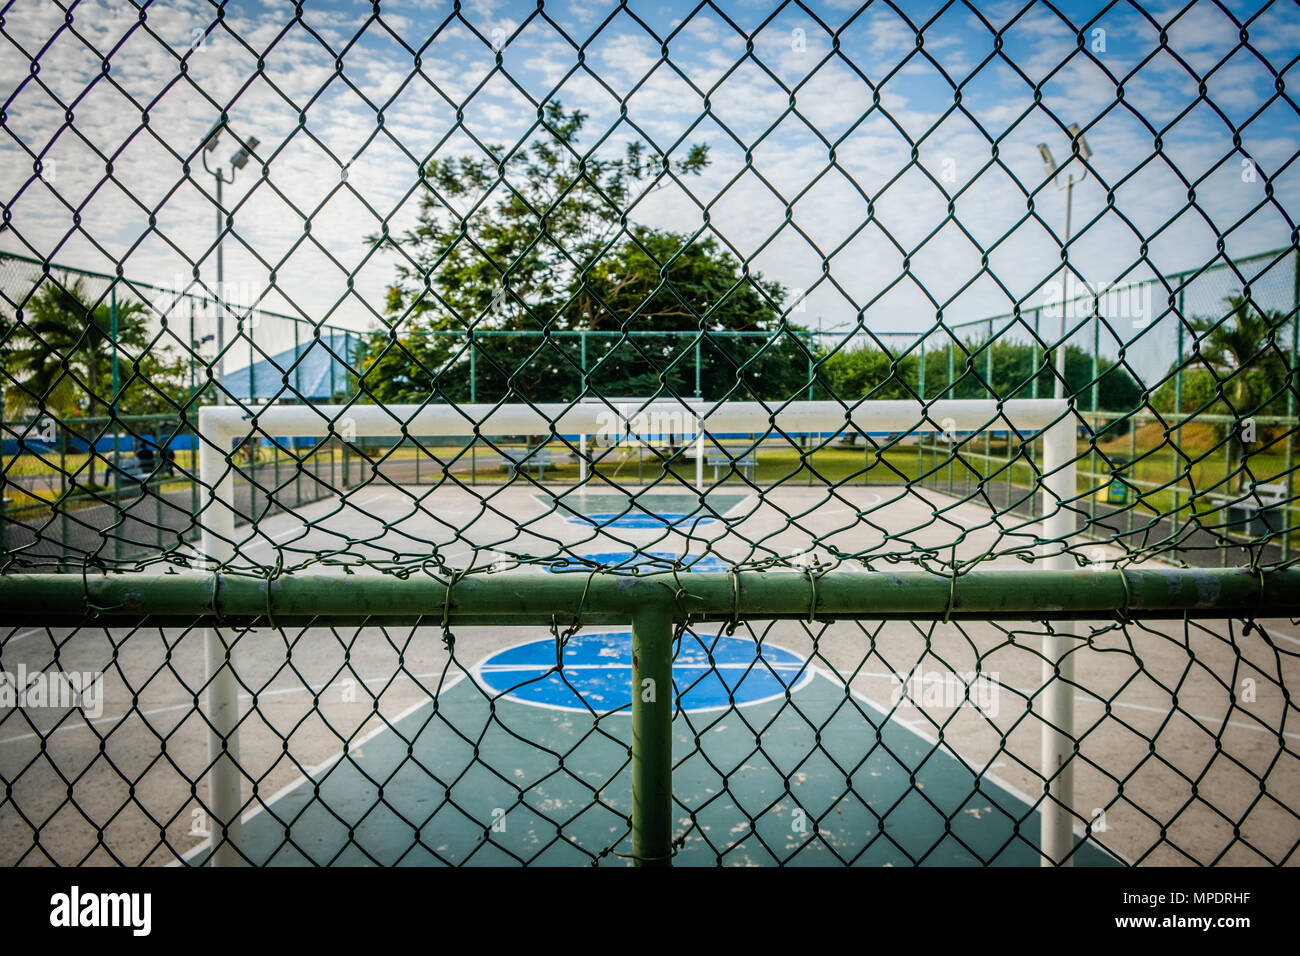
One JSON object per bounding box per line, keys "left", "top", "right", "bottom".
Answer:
{"left": 1040, "top": 414, "right": 1078, "bottom": 866}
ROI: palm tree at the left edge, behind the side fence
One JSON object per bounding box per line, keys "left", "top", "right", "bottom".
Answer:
{"left": 4, "top": 278, "right": 148, "bottom": 484}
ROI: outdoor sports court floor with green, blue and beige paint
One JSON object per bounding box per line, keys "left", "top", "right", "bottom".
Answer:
{"left": 0, "top": 476, "right": 1300, "bottom": 865}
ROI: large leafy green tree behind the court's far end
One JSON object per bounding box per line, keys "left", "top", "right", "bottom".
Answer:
{"left": 359, "top": 103, "right": 807, "bottom": 402}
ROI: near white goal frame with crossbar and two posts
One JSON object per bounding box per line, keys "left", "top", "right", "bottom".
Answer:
{"left": 199, "top": 398, "right": 1078, "bottom": 866}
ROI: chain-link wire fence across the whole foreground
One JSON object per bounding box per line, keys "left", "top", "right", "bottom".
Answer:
{"left": 0, "top": 0, "right": 1300, "bottom": 866}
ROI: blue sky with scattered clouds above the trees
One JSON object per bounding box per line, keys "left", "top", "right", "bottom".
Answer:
{"left": 0, "top": 0, "right": 1300, "bottom": 369}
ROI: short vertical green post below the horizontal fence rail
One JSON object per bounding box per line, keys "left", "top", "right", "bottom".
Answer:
{"left": 632, "top": 602, "right": 673, "bottom": 866}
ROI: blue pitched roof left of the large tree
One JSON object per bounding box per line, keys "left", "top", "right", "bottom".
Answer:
{"left": 221, "top": 332, "right": 363, "bottom": 402}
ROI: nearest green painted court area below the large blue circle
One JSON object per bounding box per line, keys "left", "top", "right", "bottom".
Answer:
{"left": 190, "top": 634, "right": 1118, "bottom": 866}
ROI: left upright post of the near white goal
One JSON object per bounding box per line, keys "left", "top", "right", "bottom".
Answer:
{"left": 199, "top": 407, "right": 242, "bottom": 866}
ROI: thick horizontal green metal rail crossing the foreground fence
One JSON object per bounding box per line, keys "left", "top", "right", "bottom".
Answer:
{"left": 0, "top": 568, "right": 1300, "bottom": 627}
